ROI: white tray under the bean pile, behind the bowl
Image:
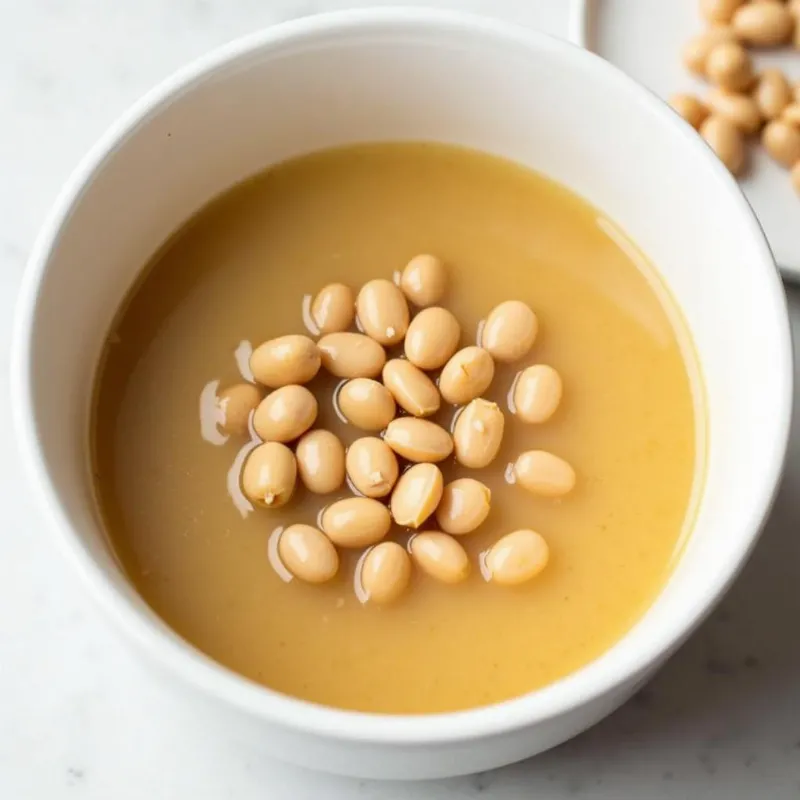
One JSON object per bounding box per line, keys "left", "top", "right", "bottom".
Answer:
{"left": 571, "top": 0, "right": 800, "bottom": 281}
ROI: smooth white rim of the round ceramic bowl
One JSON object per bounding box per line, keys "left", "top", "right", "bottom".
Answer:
{"left": 10, "top": 7, "right": 793, "bottom": 745}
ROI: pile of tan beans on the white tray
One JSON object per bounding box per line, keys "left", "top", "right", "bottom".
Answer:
{"left": 670, "top": 0, "right": 800, "bottom": 193}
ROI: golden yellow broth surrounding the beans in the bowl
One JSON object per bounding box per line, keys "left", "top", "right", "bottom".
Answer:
{"left": 94, "top": 144, "right": 701, "bottom": 713}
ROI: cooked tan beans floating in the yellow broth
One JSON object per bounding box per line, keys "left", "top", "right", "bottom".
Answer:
{"left": 218, "top": 255, "right": 575, "bottom": 603}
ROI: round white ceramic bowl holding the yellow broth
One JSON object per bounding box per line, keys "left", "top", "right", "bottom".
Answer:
{"left": 12, "top": 9, "right": 792, "bottom": 779}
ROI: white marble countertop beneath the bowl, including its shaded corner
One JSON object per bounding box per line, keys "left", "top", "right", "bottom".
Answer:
{"left": 0, "top": 0, "right": 800, "bottom": 800}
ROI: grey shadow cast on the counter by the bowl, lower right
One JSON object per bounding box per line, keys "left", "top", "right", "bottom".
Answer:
{"left": 484, "top": 287, "right": 800, "bottom": 796}
